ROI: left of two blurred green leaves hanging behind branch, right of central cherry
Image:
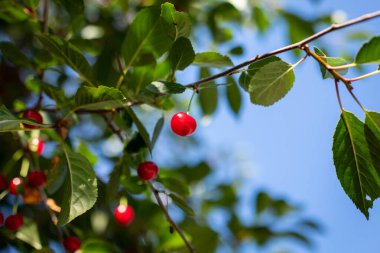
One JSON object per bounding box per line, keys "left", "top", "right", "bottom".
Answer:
{"left": 199, "top": 68, "right": 218, "bottom": 115}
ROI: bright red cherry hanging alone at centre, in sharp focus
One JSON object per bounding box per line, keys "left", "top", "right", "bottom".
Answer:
{"left": 170, "top": 112, "right": 197, "bottom": 136}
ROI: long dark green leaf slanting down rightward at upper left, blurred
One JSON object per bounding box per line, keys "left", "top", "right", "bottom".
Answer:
{"left": 35, "top": 34, "right": 96, "bottom": 86}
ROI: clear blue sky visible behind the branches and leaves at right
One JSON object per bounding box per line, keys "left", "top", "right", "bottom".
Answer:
{"left": 171, "top": 0, "right": 380, "bottom": 253}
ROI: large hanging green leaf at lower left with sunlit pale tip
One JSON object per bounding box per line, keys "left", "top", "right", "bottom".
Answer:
{"left": 58, "top": 149, "right": 98, "bottom": 226}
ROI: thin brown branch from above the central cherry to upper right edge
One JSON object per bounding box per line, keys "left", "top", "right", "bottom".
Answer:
{"left": 186, "top": 11, "right": 380, "bottom": 89}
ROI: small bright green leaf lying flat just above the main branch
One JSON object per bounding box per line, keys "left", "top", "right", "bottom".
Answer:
{"left": 193, "top": 52, "right": 234, "bottom": 68}
